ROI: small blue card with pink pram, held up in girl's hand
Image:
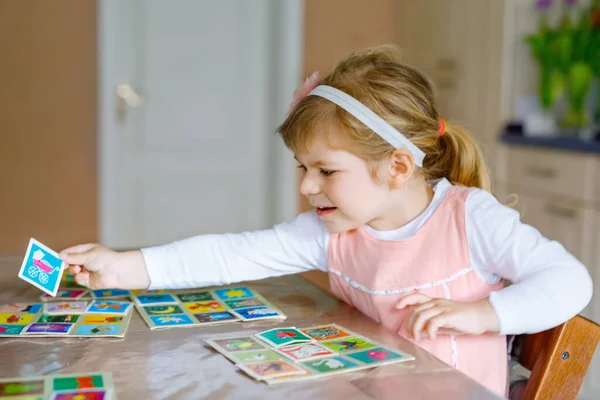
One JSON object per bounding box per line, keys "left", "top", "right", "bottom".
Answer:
{"left": 19, "top": 238, "right": 65, "bottom": 296}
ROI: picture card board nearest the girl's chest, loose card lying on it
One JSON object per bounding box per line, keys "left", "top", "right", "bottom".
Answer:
{"left": 206, "top": 324, "right": 415, "bottom": 385}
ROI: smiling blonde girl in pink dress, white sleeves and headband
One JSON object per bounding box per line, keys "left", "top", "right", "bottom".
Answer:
{"left": 61, "top": 46, "right": 592, "bottom": 395}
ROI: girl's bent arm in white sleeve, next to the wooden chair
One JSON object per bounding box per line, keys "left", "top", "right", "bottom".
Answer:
{"left": 466, "top": 190, "right": 593, "bottom": 335}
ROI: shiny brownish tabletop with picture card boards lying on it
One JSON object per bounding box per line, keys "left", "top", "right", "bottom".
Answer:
{"left": 0, "top": 255, "right": 500, "bottom": 400}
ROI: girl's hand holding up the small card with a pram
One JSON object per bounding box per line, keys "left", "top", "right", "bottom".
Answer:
{"left": 59, "top": 243, "right": 150, "bottom": 289}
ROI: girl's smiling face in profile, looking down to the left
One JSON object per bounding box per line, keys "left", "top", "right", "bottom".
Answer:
{"left": 296, "top": 140, "right": 390, "bottom": 233}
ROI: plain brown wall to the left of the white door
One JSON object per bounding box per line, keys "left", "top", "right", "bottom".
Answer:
{"left": 0, "top": 0, "right": 97, "bottom": 254}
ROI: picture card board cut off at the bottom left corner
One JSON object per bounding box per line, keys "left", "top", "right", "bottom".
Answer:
{"left": 0, "top": 372, "right": 117, "bottom": 400}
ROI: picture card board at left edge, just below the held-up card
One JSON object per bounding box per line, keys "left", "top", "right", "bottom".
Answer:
{"left": 0, "top": 300, "right": 133, "bottom": 337}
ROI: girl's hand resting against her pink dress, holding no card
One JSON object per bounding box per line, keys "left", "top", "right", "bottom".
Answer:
{"left": 396, "top": 293, "right": 499, "bottom": 341}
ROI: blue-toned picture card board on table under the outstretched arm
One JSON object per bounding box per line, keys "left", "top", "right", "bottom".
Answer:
{"left": 132, "top": 287, "right": 286, "bottom": 329}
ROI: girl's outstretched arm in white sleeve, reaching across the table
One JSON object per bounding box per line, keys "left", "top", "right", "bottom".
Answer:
{"left": 141, "top": 211, "right": 329, "bottom": 289}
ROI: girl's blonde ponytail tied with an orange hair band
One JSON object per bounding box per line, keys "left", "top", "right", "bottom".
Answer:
{"left": 424, "top": 124, "right": 491, "bottom": 192}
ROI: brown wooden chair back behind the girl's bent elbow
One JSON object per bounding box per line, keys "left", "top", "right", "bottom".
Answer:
{"left": 510, "top": 315, "right": 600, "bottom": 400}
